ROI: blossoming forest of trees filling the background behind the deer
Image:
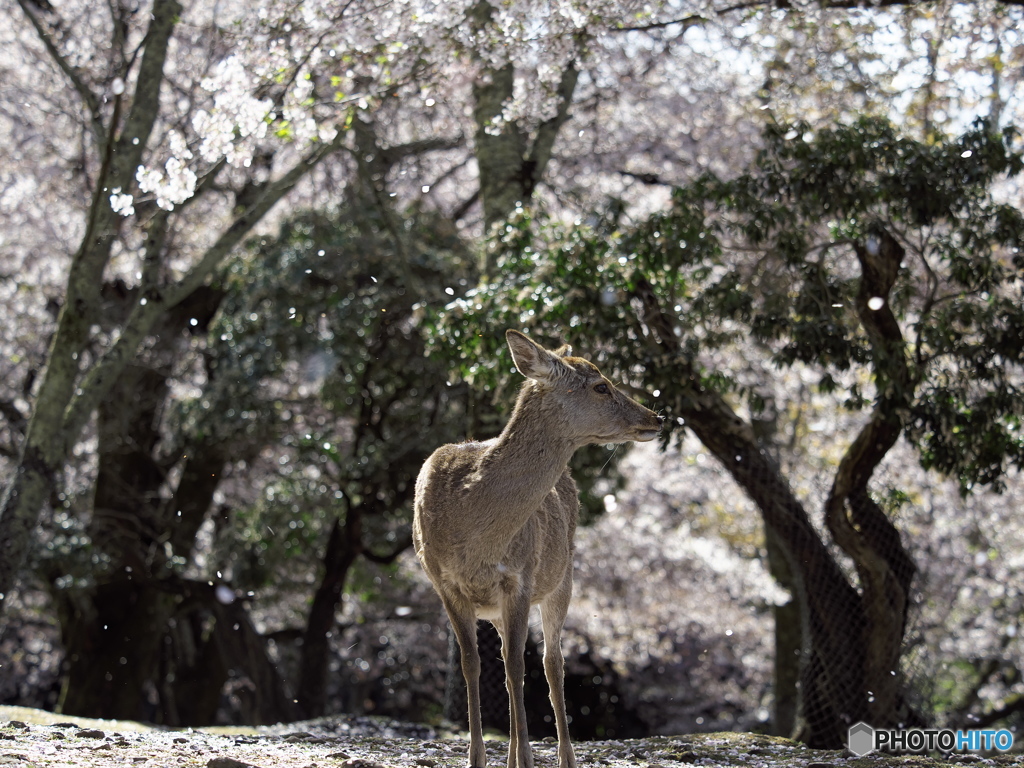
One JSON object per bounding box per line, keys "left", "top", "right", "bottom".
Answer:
{"left": 0, "top": 0, "right": 1024, "bottom": 746}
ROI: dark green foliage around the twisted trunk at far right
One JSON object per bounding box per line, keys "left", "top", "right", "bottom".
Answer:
{"left": 708, "top": 120, "right": 1024, "bottom": 490}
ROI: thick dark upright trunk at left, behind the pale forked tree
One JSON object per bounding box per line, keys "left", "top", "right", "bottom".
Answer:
{"left": 57, "top": 367, "right": 174, "bottom": 720}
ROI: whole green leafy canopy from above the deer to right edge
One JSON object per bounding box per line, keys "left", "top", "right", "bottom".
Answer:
{"left": 434, "top": 119, "right": 1024, "bottom": 492}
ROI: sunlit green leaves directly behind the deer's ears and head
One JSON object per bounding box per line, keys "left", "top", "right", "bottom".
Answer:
{"left": 428, "top": 209, "right": 663, "bottom": 524}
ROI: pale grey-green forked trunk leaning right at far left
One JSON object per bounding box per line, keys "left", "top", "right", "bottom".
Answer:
{"left": 0, "top": 54, "right": 345, "bottom": 616}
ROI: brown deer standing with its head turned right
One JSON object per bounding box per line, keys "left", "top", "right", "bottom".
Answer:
{"left": 413, "top": 330, "right": 663, "bottom": 768}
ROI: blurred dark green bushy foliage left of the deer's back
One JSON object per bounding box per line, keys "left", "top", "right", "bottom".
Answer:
{"left": 205, "top": 202, "right": 471, "bottom": 589}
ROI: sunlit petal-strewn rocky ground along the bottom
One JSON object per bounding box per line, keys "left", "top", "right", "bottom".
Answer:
{"left": 0, "top": 707, "right": 1024, "bottom": 768}
